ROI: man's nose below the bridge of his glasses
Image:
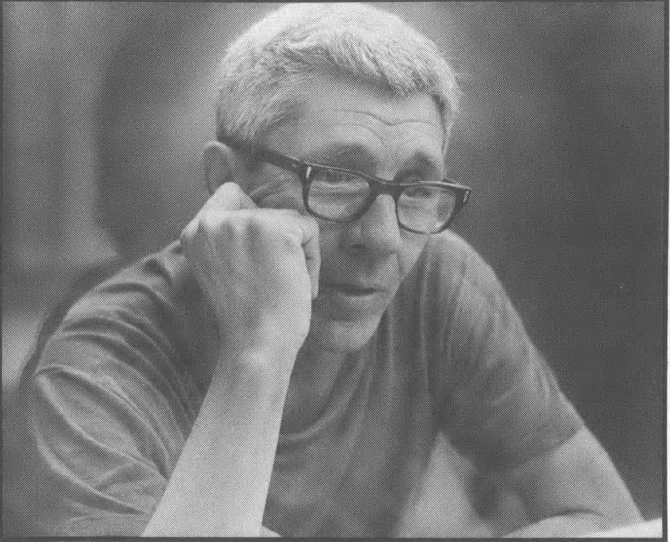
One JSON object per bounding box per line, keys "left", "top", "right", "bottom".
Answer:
{"left": 346, "top": 194, "right": 402, "bottom": 255}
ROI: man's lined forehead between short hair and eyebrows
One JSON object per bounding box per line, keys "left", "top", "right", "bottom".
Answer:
{"left": 268, "top": 77, "right": 444, "bottom": 167}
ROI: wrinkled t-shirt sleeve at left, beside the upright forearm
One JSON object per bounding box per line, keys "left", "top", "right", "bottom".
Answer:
{"left": 22, "top": 310, "right": 197, "bottom": 536}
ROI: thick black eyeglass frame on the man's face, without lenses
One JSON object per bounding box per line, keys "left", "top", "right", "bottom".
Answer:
{"left": 217, "top": 135, "right": 472, "bottom": 235}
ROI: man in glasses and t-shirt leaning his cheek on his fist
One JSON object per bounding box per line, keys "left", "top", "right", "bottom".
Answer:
{"left": 18, "top": 4, "right": 639, "bottom": 537}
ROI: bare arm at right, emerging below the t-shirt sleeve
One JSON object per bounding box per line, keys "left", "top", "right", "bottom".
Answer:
{"left": 500, "top": 428, "right": 642, "bottom": 538}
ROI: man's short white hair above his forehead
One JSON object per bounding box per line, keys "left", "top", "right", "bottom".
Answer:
{"left": 216, "top": 2, "right": 460, "bottom": 150}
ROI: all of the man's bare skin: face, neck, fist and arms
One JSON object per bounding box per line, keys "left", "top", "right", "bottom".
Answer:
{"left": 144, "top": 78, "right": 639, "bottom": 536}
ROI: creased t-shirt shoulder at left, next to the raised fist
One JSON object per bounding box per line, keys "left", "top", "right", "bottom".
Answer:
{"left": 24, "top": 245, "right": 205, "bottom": 388}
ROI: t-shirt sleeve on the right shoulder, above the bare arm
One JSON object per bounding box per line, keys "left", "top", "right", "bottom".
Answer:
{"left": 442, "top": 238, "right": 583, "bottom": 470}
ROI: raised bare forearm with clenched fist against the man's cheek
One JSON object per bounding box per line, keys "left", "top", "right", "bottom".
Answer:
{"left": 144, "top": 183, "right": 319, "bottom": 537}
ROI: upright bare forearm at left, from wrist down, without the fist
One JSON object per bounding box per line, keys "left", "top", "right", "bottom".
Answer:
{"left": 143, "top": 349, "right": 295, "bottom": 537}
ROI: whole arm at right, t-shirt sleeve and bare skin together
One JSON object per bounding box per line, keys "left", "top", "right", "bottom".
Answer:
{"left": 438, "top": 245, "right": 639, "bottom": 537}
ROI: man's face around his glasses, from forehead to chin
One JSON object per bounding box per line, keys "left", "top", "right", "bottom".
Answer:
{"left": 247, "top": 78, "right": 444, "bottom": 352}
